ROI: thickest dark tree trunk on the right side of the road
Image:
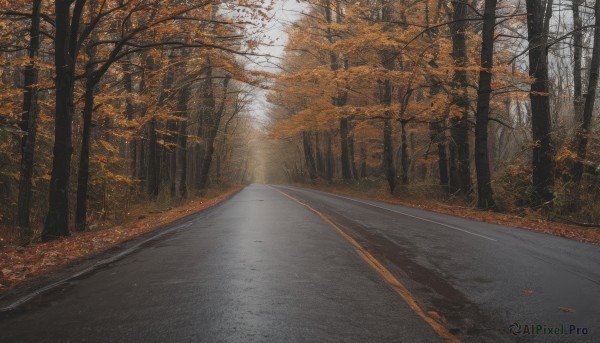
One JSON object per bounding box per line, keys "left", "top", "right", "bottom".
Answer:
{"left": 526, "top": 0, "right": 554, "bottom": 206}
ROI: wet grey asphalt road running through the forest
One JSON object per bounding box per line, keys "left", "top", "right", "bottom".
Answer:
{"left": 0, "top": 185, "right": 600, "bottom": 342}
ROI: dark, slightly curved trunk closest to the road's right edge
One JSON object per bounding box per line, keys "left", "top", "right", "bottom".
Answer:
{"left": 475, "top": 0, "right": 497, "bottom": 210}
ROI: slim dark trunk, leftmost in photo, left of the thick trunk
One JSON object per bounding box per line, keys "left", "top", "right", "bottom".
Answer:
{"left": 17, "top": 0, "right": 42, "bottom": 245}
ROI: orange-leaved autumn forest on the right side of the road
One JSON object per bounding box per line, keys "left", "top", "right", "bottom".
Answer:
{"left": 265, "top": 0, "right": 600, "bottom": 226}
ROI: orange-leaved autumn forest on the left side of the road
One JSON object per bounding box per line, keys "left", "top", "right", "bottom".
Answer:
{"left": 0, "top": 0, "right": 268, "bottom": 245}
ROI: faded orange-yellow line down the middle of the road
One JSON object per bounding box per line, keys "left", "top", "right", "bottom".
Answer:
{"left": 271, "top": 187, "right": 460, "bottom": 342}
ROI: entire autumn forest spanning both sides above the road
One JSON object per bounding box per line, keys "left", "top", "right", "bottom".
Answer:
{"left": 0, "top": 0, "right": 600, "bottom": 250}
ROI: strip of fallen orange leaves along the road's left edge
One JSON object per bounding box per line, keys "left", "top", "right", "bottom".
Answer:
{"left": 0, "top": 186, "right": 243, "bottom": 313}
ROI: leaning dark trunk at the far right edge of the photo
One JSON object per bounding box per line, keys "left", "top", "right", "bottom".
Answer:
{"left": 573, "top": 1, "right": 600, "bottom": 183}
